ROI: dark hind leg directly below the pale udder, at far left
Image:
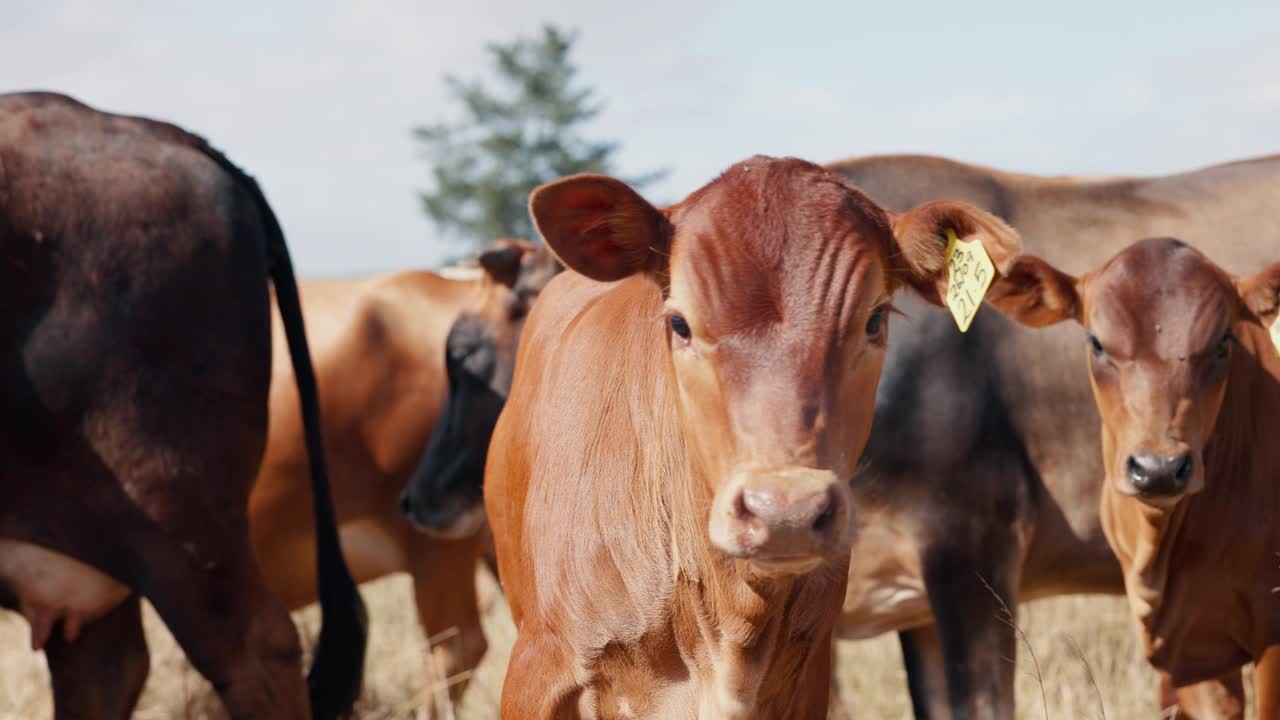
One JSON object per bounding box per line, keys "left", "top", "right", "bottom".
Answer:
{"left": 45, "top": 594, "right": 151, "bottom": 720}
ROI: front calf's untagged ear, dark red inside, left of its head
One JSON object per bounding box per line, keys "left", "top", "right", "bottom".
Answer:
{"left": 529, "top": 176, "right": 671, "bottom": 282}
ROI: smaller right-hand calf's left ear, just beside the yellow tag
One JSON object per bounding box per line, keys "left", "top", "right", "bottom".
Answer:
{"left": 987, "top": 255, "right": 1084, "bottom": 328}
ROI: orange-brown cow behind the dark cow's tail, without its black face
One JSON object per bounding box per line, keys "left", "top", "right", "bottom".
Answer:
{"left": 250, "top": 241, "right": 554, "bottom": 708}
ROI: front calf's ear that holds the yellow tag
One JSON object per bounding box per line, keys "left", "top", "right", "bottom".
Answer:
{"left": 890, "top": 200, "right": 1023, "bottom": 305}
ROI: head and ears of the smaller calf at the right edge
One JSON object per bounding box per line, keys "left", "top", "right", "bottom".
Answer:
{"left": 992, "top": 238, "right": 1280, "bottom": 509}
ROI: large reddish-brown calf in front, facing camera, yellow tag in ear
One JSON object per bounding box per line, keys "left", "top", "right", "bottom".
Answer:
{"left": 485, "top": 158, "right": 1018, "bottom": 719}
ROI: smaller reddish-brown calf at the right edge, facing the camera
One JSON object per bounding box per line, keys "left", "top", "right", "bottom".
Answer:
{"left": 992, "top": 236, "right": 1280, "bottom": 717}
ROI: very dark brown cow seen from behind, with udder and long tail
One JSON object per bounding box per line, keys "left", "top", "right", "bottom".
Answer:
{"left": 0, "top": 94, "right": 365, "bottom": 719}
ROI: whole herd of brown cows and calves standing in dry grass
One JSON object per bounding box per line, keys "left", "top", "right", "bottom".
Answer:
{"left": 0, "top": 94, "right": 1280, "bottom": 720}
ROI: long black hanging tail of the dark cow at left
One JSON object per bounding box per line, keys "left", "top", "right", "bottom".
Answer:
{"left": 192, "top": 141, "right": 369, "bottom": 720}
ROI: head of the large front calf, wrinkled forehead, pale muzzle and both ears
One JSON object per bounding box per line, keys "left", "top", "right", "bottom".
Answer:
{"left": 530, "top": 158, "right": 1018, "bottom": 574}
